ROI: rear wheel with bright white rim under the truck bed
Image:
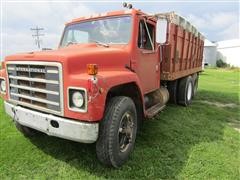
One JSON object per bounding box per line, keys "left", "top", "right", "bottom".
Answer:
{"left": 178, "top": 76, "right": 193, "bottom": 106}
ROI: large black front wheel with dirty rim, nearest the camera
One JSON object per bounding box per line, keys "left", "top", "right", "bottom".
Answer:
{"left": 96, "top": 96, "right": 137, "bottom": 168}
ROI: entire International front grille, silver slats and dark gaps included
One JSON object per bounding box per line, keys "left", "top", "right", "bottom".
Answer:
{"left": 7, "top": 61, "right": 63, "bottom": 115}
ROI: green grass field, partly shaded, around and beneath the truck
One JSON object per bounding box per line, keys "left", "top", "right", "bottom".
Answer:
{"left": 0, "top": 69, "right": 240, "bottom": 179}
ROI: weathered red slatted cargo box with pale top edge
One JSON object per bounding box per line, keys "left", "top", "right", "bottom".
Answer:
{"left": 156, "top": 12, "right": 204, "bottom": 81}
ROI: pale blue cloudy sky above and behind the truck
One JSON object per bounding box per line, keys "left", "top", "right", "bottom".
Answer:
{"left": 0, "top": 0, "right": 240, "bottom": 61}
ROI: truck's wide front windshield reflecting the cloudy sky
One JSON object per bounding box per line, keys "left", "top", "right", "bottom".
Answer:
{"left": 60, "top": 16, "right": 131, "bottom": 47}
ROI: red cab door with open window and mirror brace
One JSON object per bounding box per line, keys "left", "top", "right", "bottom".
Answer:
{"left": 136, "top": 18, "right": 160, "bottom": 94}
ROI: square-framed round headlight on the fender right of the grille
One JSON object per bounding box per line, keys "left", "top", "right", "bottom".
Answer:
{"left": 68, "top": 87, "right": 87, "bottom": 112}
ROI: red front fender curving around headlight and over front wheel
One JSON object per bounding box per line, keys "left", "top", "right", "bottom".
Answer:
{"left": 64, "top": 70, "right": 143, "bottom": 122}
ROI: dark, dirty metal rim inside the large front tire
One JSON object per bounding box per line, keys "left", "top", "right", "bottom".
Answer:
{"left": 118, "top": 112, "right": 134, "bottom": 152}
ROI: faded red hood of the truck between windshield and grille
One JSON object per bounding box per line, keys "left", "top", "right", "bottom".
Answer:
{"left": 5, "top": 43, "right": 130, "bottom": 74}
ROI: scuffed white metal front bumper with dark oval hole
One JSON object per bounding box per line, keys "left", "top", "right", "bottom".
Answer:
{"left": 4, "top": 101, "right": 99, "bottom": 143}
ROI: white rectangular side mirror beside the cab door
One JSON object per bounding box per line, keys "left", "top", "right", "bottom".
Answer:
{"left": 156, "top": 19, "right": 168, "bottom": 44}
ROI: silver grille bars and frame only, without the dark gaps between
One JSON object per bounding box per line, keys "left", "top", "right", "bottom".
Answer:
{"left": 6, "top": 61, "right": 63, "bottom": 116}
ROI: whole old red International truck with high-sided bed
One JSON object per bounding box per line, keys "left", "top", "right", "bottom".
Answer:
{"left": 0, "top": 5, "right": 204, "bottom": 167}
